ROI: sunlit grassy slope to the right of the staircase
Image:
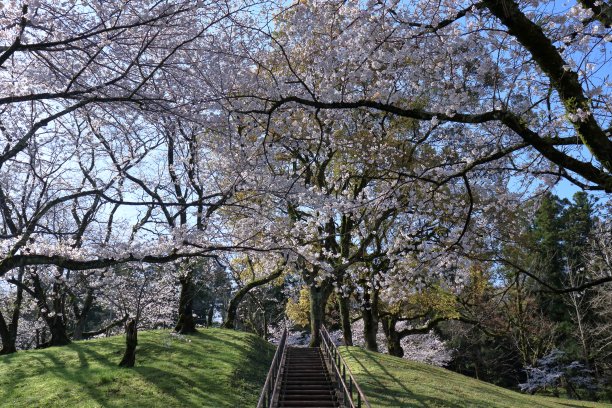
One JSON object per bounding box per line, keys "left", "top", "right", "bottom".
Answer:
{"left": 341, "top": 347, "right": 612, "bottom": 408}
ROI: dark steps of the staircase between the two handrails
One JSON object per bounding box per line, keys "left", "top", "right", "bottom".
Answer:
{"left": 276, "top": 347, "right": 340, "bottom": 408}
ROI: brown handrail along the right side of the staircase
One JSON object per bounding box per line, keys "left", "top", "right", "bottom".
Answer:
{"left": 321, "top": 326, "right": 371, "bottom": 408}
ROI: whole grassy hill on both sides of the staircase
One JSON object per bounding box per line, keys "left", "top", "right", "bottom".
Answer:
{"left": 0, "top": 329, "right": 612, "bottom": 408}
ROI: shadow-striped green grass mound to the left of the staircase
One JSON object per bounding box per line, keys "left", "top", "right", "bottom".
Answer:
{"left": 0, "top": 329, "right": 274, "bottom": 408}
